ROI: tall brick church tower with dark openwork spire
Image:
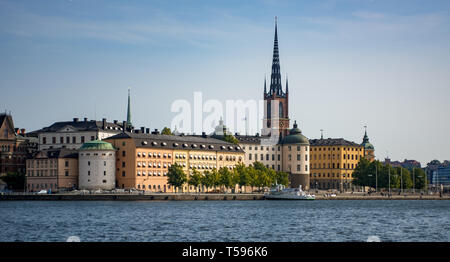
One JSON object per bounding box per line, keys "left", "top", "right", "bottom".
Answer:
{"left": 263, "top": 17, "right": 289, "bottom": 138}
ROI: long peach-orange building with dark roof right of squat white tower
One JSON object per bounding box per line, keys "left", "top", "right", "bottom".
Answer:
{"left": 105, "top": 132, "right": 244, "bottom": 192}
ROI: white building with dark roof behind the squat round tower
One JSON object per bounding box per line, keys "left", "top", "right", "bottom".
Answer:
{"left": 36, "top": 118, "right": 126, "bottom": 150}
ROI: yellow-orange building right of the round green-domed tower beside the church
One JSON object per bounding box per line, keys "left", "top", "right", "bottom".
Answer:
{"left": 309, "top": 138, "right": 364, "bottom": 191}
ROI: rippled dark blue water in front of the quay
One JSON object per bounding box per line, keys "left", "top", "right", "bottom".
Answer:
{"left": 0, "top": 200, "right": 450, "bottom": 242}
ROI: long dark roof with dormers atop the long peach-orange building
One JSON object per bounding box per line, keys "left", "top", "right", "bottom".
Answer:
{"left": 105, "top": 132, "right": 244, "bottom": 152}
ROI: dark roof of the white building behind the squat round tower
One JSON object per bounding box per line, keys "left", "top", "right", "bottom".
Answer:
{"left": 35, "top": 119, "right": 122, "bottom": 133}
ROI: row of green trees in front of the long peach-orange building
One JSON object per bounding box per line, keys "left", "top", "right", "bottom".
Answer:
{"left": 167, "top": 162, "right": 289, "bottom": 191}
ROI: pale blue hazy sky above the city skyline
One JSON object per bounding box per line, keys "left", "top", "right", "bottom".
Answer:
{"left": 0, "top": 0, "right": 450, "bottom": 166}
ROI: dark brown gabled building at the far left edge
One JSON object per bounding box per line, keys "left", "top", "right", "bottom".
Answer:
{"left": 0, "top": 113, "right": 37, "bottom": 177}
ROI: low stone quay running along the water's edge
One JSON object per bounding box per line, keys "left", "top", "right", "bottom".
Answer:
{"left": 0, "top": 193, "right": 450, "bottom": 201}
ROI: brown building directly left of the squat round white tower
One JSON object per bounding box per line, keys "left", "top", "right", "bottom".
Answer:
{"left": 26, "top": 148, "right": 78, "bottom": 192}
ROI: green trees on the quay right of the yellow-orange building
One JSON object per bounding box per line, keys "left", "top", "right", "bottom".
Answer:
{"left": 352, "top": 158, "right": 427, "bottom": 189}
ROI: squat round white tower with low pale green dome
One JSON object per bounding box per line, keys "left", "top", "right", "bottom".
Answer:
{"left": 78, "top": 140, "right": 116, "bottom": 190}
